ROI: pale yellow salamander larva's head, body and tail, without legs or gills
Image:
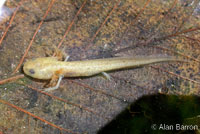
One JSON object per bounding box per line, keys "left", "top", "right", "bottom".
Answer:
{"left": 23, "top": 57, "right": 177, "bottom": 79}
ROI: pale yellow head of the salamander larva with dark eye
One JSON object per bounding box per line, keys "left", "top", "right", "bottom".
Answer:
{"left": 23, "top": 57, "right": 56, "bottom": 79}
